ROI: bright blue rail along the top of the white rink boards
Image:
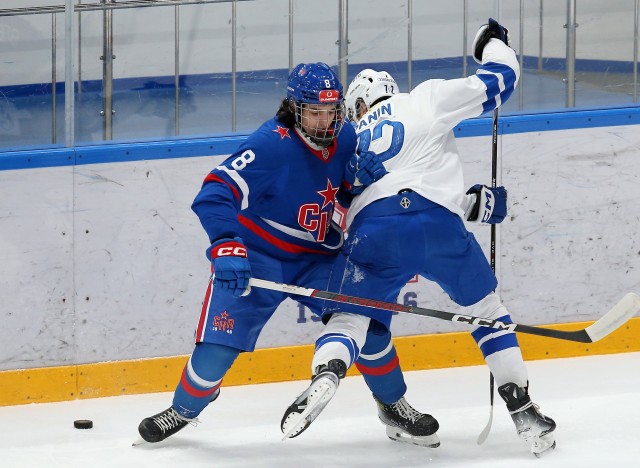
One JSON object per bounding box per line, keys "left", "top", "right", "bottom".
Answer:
{"left": 0, "top": 106, "right": 640, "bottom": 170}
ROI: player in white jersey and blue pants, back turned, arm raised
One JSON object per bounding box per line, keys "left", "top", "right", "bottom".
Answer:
{"left": 282, "top": 19, "right": 555, "bottom": 456}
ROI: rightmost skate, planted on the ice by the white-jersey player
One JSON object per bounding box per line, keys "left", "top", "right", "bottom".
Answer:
{"left": 498, "top": 383, "right": 556, "bottom": 457}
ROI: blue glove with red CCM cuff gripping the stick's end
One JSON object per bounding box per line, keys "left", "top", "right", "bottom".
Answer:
{"left": 207, "top": 237, "right": 251, "bottom": 297}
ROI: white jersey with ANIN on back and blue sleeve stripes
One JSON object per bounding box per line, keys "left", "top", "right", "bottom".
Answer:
{"left": 347, "top": 39, "right": 520, "bottom": 227}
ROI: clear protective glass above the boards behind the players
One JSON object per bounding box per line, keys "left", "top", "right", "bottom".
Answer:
{"left": 0, "top": 0, "right": 638, "bottom": 151}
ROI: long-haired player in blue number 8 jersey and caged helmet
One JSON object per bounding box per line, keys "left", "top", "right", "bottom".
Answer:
{"left": 139, "top": 63, "right": 432, "bottom": 442}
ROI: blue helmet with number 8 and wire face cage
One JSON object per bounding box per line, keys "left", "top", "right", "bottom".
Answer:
{"left": 287, "top": 62, "right": 345, "bottom": 147}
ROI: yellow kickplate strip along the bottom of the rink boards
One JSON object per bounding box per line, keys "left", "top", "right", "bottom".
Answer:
{"left": 0, "top": 317, "right": 640, "bottom": 406}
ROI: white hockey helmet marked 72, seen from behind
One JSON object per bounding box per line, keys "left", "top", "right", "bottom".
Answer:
{"left": 345, "top": 68, "right": 399, "bottom": 122}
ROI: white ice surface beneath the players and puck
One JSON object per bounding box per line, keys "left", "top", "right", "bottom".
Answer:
{"left": 0, "top": 353, "right": 640, "bottom": 468}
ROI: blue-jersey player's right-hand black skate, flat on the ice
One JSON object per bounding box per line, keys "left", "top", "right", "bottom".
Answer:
{"left": 373, "top": 395, "right": 440, "bottom": 448}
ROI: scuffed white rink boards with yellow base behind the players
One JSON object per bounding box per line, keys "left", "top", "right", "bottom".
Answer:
{"left": 0, "top": 111, "right": 640, "bottom": 405}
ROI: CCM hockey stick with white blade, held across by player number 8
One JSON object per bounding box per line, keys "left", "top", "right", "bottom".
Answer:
{"left": 249, "top": 278, "right": 640, "bottom": 343}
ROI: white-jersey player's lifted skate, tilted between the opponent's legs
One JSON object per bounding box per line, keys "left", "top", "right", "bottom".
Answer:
{"left": 280, "top": 359, "right": 347, "bottom": 440}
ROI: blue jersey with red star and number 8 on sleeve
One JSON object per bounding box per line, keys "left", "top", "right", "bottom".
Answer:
{"left": 192, "top": 118, "right": 356, "bottom": 260}
